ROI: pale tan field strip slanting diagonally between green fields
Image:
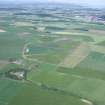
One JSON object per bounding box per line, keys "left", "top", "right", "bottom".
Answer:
{"left": 59, "top": 43, "right": 91, "bottom": 68}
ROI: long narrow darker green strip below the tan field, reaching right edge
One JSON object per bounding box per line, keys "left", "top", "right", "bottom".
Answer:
{"left": 57, "top": 66, "right": 105, "bottom": 80}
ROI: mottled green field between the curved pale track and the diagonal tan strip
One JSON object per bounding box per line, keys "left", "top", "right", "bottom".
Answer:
{"left": 27, "top": 41, "right": 80, "bottom": 64}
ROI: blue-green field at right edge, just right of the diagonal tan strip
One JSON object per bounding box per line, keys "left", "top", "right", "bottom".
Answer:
{"left": 78, "top": 52, "right": 105, "bottom": 72}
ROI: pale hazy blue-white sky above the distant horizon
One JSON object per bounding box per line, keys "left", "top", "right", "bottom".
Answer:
{"left": 0, "top": 0, "right": 105, "bottom": 7}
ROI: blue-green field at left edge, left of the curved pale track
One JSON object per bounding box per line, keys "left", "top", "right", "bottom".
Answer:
{"left": 0, "top": 33, "right": 24, "bottom": 60}
